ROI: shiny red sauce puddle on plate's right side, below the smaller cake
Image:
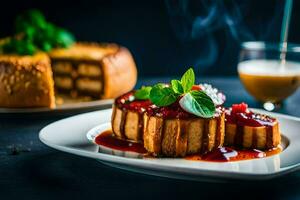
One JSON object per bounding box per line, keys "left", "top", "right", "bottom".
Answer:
{"left": 185, "top": 147, "right": 281, "bottom": 162}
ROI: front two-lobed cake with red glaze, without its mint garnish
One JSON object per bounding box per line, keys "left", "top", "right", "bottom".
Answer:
{"left": 112, "top": 92, "right": 225, "bottom": 157}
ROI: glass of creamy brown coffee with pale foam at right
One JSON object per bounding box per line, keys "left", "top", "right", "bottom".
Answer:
{"left": 238, "top": 42, "right": 300, "bottom": 111}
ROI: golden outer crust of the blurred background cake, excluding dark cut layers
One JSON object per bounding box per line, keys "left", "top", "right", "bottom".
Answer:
{"left": 0, "top": 43, "right": 137, "bottom": 108}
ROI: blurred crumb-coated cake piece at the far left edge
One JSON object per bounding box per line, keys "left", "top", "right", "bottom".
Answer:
{"left": 0, "top": 53, "right": 55, "bottom": 108}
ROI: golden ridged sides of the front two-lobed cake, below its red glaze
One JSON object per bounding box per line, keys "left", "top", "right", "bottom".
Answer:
{"left": 111, "top": 101, "right": 225, "bottom": 157}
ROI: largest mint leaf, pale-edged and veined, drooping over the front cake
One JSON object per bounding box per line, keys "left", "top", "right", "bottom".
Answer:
{"left": 179, "top": 90, "right": 216, "bottom": 118}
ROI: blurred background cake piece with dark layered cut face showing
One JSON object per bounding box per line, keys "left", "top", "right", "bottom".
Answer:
{"left": 49, "top": 43, "right": 137, "bottom": 99}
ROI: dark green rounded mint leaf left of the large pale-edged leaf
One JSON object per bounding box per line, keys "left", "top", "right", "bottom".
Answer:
{"left": 150, "top": 83, "right": 178, "bottom": 106}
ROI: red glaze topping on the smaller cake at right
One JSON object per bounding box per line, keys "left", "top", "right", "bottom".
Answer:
{"left": 226, "top": 103, "right": 276, "bottom": 127}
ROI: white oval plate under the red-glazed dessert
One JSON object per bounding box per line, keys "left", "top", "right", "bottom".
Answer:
{"left": 39, "top": 109, "right": 300, "bottom": 180}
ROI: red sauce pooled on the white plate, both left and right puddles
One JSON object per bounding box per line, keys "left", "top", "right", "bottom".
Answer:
{"left": 95, "top": 130, "right": 282, "bottom": 162}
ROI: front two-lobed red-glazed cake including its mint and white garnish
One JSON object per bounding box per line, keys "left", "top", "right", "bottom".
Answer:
{"left": 112, "top": 70, "right": 225, "bottom": 157}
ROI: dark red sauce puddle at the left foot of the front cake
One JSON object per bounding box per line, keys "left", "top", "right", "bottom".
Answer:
{"left": 95, "top": 130, "right": 147, "bottom": 154}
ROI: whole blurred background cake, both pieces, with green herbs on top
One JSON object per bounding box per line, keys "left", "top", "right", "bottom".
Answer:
{"left": 0, "top": 10, "right": 137, "bottom": 108}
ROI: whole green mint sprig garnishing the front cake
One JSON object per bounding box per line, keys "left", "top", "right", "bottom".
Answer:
{"left": 135, "top": 68, "right": 216, "bottom": 118}
